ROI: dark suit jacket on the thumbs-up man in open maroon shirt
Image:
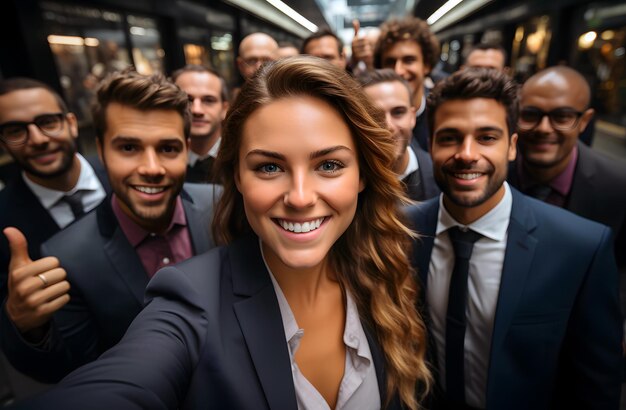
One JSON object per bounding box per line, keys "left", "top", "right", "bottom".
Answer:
{"left": 0, "top": 184, "right": 217, "bottom": 382}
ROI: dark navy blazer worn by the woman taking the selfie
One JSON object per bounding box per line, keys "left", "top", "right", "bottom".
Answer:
{"left": 20, "top": 235, "right": 400, "bottom": 410}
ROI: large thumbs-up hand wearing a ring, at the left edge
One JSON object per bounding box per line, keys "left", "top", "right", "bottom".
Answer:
{"left": 3, "top": 228, "right": 70, "bottom": 335}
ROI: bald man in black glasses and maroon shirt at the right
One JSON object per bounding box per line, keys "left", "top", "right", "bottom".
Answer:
{"left": 509, "top": 66, "right": 626, "bottom": 282}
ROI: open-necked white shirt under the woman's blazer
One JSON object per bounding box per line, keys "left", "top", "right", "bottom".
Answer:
{"left": 259, "top": 240, "right": 381, "bottom": 410}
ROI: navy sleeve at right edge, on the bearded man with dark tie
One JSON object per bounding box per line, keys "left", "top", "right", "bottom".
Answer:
{"left": 559, "top": 227, "right": 622, "bottom": 409}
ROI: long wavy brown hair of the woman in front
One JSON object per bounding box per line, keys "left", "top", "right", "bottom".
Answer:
{"left": 213, "top": 56, "right": 431, "bottom": 409}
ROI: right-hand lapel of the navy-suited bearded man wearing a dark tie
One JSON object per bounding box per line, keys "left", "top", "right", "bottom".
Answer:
{"left": 487, "top": 189, "right": 537, "bottom": 407}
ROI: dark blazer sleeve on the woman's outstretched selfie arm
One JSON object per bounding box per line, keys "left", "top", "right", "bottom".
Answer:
{"left": 13, "top": 267, "right": 208, "bottom": 410}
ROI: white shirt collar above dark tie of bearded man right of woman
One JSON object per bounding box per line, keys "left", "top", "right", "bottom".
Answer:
{"left": 436, "top": 182, "right": 513, "bottom": 242}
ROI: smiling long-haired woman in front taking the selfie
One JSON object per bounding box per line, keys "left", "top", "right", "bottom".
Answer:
{"left": 18, "top": 57, "right": 430, "bottom": 409}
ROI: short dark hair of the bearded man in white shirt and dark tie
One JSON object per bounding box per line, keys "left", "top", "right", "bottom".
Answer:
{"left": 426, "top": 67, "right": 519, "bottom": 137}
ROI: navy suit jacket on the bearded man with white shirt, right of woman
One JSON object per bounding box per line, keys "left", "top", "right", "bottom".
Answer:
{"left": 408, "top": 189, "right": 622, "bottom": 410}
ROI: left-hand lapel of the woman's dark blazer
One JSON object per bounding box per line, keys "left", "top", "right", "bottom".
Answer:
{"left": 229, "top": 236, "right": 297, "bottom": 409}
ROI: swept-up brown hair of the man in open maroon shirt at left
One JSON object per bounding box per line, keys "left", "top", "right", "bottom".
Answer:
{"left": 91, "top": 70, "right": 191, "bottom": 142}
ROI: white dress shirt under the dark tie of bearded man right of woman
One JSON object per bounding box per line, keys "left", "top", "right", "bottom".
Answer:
{"left": 426, "top": 182, "right": 513, "bottom": 408}
